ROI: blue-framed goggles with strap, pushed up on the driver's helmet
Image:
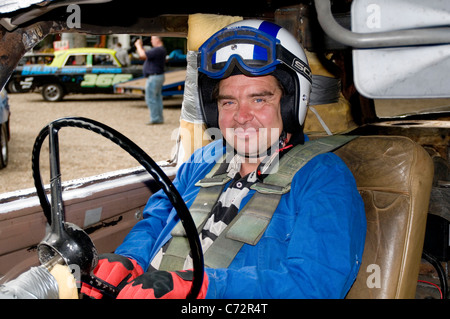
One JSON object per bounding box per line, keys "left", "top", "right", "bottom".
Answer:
{"left": 198, "top": 27, "right": 311, "bottom": 81}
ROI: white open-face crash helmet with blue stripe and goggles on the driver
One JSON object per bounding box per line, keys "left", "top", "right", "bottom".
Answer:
{"left": 198, "top": 20, "right": 312, "bottom": 136}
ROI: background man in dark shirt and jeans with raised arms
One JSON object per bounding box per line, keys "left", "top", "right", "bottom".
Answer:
{"left": 134, "top": 36, "right": 167, "bottom": 125}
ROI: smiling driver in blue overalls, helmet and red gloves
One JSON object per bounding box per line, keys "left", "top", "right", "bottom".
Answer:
{"left": 82, "top": 20, "right": 366, "bottom": 299}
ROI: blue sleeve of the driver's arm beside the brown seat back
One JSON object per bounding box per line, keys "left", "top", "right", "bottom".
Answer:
{"left": 206, "top": 154, "right": 366, "bottom": 298}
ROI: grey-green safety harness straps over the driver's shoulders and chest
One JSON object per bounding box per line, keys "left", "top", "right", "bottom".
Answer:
{"left": 159, "top": 135, "right": 356, "bottom": 271}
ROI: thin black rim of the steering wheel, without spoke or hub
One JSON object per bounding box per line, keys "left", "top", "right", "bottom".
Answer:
{"left": 31, "top": 117, "right": 204, "bottom": 299}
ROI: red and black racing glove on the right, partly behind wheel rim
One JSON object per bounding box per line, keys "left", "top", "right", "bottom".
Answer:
{"left": 117, "top": 270, "right": 208, "bottom": 299}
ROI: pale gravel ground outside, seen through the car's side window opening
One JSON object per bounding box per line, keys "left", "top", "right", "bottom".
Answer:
{"left": 0, "top": 93, "right": 182, "bottom": 193}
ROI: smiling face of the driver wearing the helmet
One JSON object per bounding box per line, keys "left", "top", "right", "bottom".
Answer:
{"left": 217, "top": 75, "right": 283, "bottom": 156}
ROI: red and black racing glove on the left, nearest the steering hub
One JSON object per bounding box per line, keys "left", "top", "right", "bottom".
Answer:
{"left": 81, "top": 254, "right": 144, "bottom": 299}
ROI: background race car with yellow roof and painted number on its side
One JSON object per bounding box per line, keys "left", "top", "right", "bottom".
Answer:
{"left": 12, "top": 48, "right": 142, "bottom": 102}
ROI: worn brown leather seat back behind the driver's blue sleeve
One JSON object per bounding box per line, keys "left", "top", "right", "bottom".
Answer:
{"left": 335, "top": 136, "right": 433, "bottom": 299}
